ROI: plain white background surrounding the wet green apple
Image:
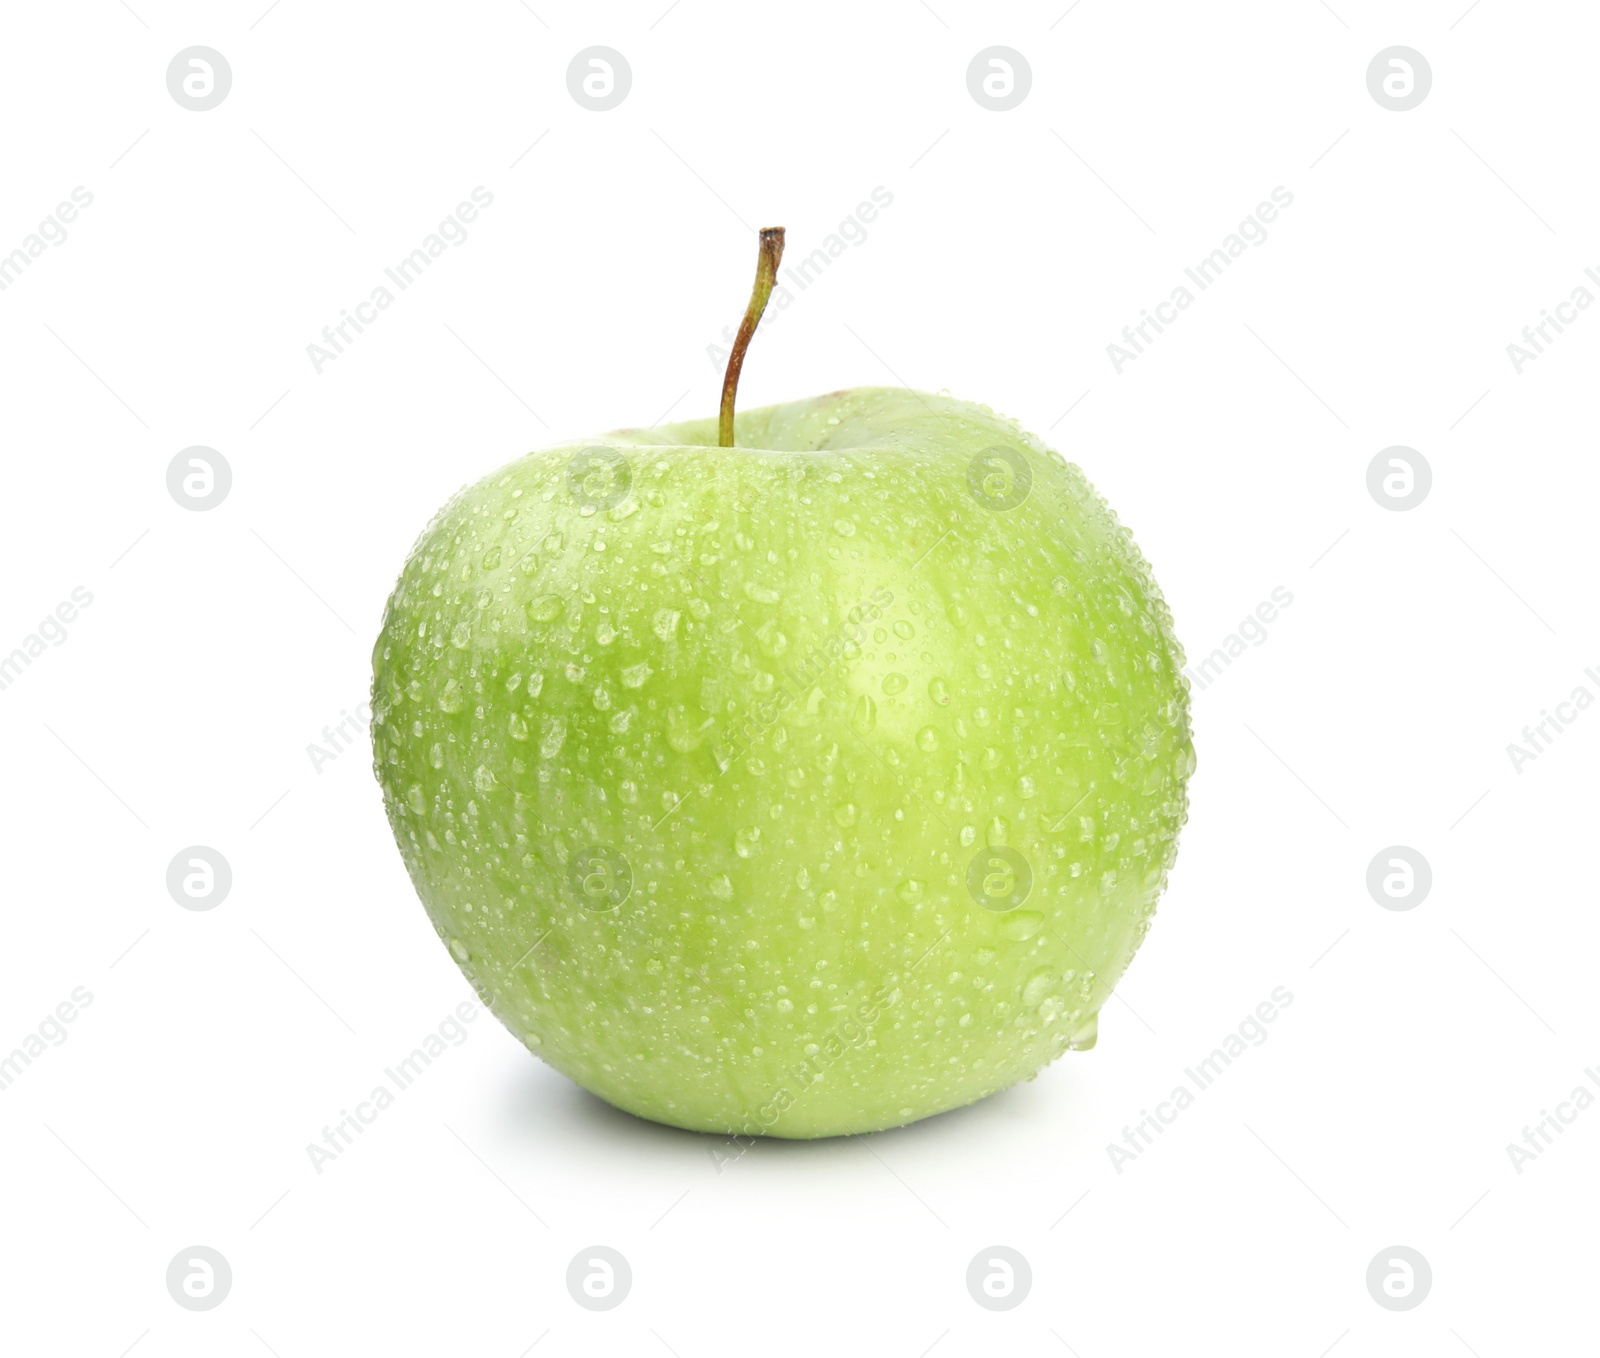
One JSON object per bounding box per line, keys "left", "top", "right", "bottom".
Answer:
{"left": 0, "top": 0, "right": 1600, "bottom": 1358}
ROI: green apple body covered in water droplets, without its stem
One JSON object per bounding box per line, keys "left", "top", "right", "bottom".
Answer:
{"left": 373, "top": 387, "right": 1194, "bottom": 1137}
